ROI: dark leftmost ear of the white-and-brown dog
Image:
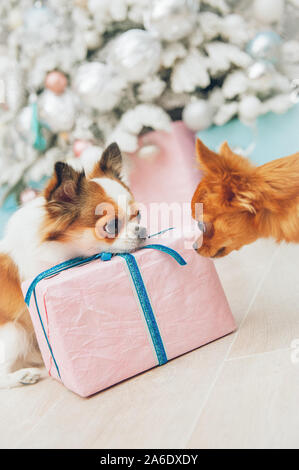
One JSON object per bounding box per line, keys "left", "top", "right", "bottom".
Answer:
{"left": 44, "top": 162, "right": 85, "bottom": 205}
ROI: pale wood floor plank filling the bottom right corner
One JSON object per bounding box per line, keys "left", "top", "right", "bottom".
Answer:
{"left": 188, "top": 350, "right": 299, "bottom": 448}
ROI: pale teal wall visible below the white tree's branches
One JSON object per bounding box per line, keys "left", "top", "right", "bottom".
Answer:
{"left": 0, "top": 104, "right": 299, "bottom": 238}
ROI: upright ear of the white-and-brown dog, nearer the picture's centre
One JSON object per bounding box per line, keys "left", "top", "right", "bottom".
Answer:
{"left": 90, "top": 142, "right": 123, "bottom": 179}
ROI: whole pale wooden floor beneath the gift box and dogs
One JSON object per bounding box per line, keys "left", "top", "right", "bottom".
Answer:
{"left": 0, "top": 240, "right": 299, "bottom": 448}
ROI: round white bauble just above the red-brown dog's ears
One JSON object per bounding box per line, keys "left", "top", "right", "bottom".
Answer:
{"left": 183, "top": 100, "right": 213, "bottom": 131}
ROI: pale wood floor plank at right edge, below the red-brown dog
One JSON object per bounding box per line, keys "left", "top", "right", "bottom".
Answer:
{"left": 230, "top": 244, "right": 299, "bottom": 357}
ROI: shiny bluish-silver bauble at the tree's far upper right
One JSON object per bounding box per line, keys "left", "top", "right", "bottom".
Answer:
{"left": 246, "top": 31, "right": 282, "bottom": 63}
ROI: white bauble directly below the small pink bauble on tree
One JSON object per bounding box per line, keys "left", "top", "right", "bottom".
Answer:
{"left": 38, "top": 90, "right": 75, "bottom": 133}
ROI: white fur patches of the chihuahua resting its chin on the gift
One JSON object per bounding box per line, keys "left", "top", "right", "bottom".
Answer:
{"left": 0, "top": 171, "right": 144, "bottom": 388}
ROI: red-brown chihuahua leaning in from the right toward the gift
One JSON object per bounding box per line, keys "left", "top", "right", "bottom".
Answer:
{"left": 191, "top": 139, "right": 299, "bottom": 258}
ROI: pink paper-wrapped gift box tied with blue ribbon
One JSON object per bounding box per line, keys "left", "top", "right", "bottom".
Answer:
{"left": 23, "top": 230, "right": 235, "bottom": 397}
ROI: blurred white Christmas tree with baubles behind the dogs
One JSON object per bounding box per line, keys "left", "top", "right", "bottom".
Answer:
{"left": 0, "top": 0, "right": 299, "bottom": 203}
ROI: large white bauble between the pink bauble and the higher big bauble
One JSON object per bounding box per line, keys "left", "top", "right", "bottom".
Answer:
{"left": 73, "top": 62, "right": 125, "bottom": 111}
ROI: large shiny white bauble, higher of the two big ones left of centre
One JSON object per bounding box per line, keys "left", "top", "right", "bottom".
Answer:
{"left": 108, "top": 29, "right": 161, "bottom": 82}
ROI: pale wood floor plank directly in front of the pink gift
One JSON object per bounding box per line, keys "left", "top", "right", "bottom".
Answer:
{"left": 15, "top": 335, "right": 233, "bottom": 448}
